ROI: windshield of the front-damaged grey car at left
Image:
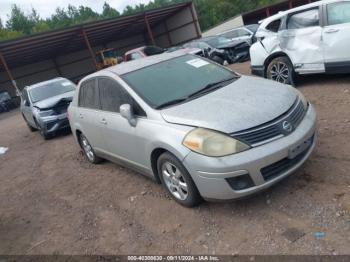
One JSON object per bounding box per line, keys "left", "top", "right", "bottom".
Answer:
{"left": 29, "top": 79, "right": 75, "bottom": 103}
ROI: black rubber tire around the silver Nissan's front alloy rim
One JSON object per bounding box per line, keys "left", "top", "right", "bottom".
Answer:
{"left": 157, "top": 152, "right": 203, "bottom": 207}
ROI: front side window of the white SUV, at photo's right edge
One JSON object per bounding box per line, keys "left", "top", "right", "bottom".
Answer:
{"left": 327, "top": 2, "right": 350, "bottom": 25}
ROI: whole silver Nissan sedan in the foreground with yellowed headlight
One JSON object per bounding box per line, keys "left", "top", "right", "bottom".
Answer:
{"left": 68, "top": 52, "right": 316, "bottom": 207}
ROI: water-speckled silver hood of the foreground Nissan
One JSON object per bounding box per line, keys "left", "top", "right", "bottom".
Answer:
{"left": 161, "top": 76, "right": 296, "bottom": 133}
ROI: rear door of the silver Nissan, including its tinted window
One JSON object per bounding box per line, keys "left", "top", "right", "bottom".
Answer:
{"left": 76, "top": 78, "right": 106, "bottom": 150}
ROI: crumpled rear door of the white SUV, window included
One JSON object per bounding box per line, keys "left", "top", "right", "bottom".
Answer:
{"left": 279, "top": 6, "right": 325, "bottom": 73}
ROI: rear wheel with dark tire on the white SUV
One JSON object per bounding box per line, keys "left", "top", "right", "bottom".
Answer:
{"left": 266, "top": 56, "right": 296, "bottom": 86}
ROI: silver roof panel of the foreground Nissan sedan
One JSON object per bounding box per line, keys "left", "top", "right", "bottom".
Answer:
{"left": 93, "top": 49, "right": 191, "bottom": 76}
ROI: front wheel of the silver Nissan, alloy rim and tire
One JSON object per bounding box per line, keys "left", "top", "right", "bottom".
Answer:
{"left": 157, "top": 153, "right": 203, "bottom": 207}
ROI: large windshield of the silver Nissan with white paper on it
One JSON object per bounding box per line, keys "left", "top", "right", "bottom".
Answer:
{"left": 122, "top": 55, "right": 237, "bottom": 108}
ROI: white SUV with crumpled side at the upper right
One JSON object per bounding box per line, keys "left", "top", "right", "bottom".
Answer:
{"left": 250, "top": 0, "right": 350, "bottom": 84}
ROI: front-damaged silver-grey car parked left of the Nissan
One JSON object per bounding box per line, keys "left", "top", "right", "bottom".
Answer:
{"left": 21, "top": 77, "right": 76, "bottom": 139}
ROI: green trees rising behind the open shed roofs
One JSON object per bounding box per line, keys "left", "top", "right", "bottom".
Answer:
{"left": 0, "top": 0, "right": 278, "bottom": 41}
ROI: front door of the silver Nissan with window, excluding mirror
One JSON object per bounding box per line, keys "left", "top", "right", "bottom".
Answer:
{"left": 98, "top": 77, "right": 146, "bottom": 169}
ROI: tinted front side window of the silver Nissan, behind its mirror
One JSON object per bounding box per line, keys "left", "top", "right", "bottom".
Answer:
{"left": 98, "top": 77, "right": 146, "bottom": 116}
